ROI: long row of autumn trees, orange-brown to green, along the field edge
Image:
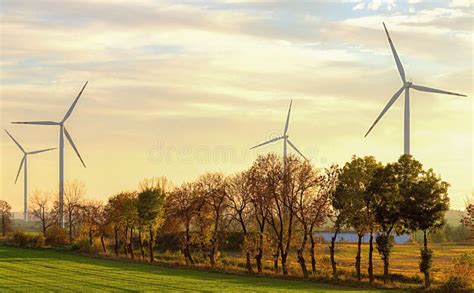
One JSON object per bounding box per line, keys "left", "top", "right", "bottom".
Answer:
{"left": 8, "top": 154, "right": 460, "bottom": 287}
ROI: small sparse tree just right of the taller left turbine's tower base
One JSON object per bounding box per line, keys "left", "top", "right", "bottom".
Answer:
{"left": 64, "top": 180, "right": 86, "bottom": 243}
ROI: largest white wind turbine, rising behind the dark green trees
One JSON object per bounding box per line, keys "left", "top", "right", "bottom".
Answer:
{"left": 364, "top": 23, "right": 466, "bottom": 155}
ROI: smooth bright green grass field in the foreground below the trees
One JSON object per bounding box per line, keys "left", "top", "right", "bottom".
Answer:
{"left": 0, "top": 246, "right": 394, "bottom": 292}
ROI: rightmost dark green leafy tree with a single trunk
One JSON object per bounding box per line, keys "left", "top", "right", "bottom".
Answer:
{"left": 402, "top": 169, "right": 449, "bottom": 288}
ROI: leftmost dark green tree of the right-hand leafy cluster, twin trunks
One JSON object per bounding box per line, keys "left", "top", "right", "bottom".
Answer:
{"left": 337, "top": 156, "right": 381, "bottom": 282}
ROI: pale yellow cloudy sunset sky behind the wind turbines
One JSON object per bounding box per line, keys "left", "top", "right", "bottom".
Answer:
{"left": 0, "top": 0, "right": 474, "bottom": 211}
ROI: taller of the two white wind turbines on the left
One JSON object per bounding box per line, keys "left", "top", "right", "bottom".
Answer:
{"left": 12, "top": 81, "right": 87, "bottom": 228}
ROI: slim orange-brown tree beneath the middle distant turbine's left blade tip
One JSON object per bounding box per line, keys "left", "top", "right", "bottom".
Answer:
{"left": 226, "top": 172, "right": 252, "bottom": 273}
